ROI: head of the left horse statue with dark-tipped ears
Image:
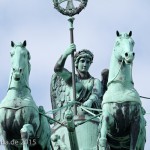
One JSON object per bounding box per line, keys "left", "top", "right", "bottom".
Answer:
{"left": 10, "top": 41, "right": 30, "bottom": 81}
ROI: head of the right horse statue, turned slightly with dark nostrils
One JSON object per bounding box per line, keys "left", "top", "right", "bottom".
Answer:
{"left": 114, "top": 31, "right": 135, "bottom": 64}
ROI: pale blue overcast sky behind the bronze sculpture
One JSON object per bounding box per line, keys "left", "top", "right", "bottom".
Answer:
{"left": 0, "top": 0, "right": 150, "bottom": 150}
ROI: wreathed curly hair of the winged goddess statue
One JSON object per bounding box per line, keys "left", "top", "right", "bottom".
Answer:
{"left": 74, "top": 49, "right": 94, "bottom": 68}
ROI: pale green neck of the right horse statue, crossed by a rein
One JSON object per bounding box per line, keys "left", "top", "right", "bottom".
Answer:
{"left": 108, "top": 54, "right": 133, "bottom": 88}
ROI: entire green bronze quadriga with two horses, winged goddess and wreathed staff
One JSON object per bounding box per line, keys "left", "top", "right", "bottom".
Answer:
{"left": 0, "top": 0, "right": 146, "bottom": 150}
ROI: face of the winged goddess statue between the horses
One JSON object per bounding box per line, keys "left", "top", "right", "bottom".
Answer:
{"left": 78, "top": 57, "right": 91, "bottom": 73}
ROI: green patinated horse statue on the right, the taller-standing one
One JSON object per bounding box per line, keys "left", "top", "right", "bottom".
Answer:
{"left": 99, "top": 31, "right": 146, "bottom": 150}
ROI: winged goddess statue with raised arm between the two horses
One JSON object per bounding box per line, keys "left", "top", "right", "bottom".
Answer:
{"left": 51, "top": 44, "right": 102, "bottom": 119}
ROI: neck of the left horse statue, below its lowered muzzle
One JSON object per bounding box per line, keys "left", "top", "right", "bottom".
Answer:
{"left": 8, "top": 67, "right": 30, "bottom": 97}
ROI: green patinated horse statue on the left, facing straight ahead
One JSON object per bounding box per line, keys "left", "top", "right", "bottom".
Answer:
{"left": 0, "top": 41, "right": 51, "bottom": 150}
